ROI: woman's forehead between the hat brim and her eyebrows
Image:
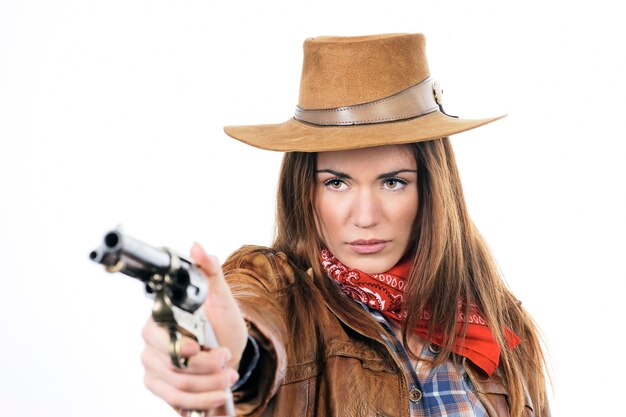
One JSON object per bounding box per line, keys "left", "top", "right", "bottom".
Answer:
{"left": 317, "top": 145, "right": 417, "bottom": 171}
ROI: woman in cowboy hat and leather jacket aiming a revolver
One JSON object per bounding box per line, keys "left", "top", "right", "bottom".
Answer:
{"left": 143, "top": 34, "right": 549, "bottom": 417}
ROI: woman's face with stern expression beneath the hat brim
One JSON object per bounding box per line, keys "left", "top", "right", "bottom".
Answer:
{"left": 313, "top": 145, "right": 418, "bottom": 273}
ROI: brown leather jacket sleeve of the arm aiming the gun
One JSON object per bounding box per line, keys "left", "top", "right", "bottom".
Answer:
{"left": 224, "top": 247, "right": 293, "bottom": 416}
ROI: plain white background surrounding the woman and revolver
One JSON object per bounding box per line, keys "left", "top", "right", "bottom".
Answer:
{"left": 0, "top": 0, "right": 626, "bottom": 417}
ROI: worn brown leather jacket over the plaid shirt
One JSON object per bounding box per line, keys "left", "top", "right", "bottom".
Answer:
{"left": 224, "top": 247, "right": 535, "bottom": 417}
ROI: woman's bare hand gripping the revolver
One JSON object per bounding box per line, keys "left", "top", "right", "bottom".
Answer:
{"left": 142, "top": 244, "right": 248, "bottom": 411}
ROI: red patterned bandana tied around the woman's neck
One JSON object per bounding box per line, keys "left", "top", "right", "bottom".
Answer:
{"left": 321, "top": 249, "right": 520, "bottom": 375}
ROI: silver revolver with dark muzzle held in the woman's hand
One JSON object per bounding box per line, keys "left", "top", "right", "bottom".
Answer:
{"left": 89, "top": 229, "right": 235, "bottom": 417}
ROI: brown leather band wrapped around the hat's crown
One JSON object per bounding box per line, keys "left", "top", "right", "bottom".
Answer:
{"left": 294, "top": 77, "right": 441, "bottom": 126}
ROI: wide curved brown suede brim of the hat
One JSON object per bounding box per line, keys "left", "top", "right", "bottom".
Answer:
{"left": 224, "top": 111, "right": 506, "bottom": 152}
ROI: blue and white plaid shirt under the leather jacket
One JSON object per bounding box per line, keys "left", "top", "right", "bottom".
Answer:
{"left": 359, "top": 303, "right": 489, "bottom": 417}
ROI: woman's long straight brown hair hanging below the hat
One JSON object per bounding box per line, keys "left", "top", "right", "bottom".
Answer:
{"left": 272, "top": 138, "right": 546, "bottom": 416}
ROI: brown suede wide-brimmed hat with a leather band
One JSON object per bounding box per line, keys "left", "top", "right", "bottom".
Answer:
{"left": 224, "top": 33, "right": 504, "bottom": 152}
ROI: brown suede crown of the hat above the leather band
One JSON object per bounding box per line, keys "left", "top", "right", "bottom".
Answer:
{"left": 298, "top": 33, "right": 430, "bottom": 109}
